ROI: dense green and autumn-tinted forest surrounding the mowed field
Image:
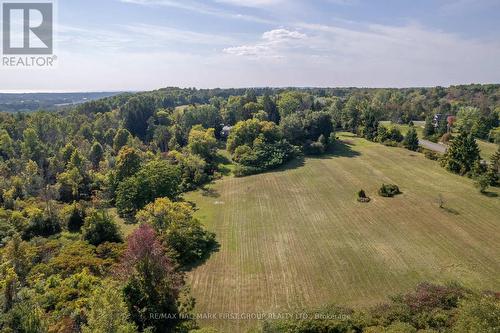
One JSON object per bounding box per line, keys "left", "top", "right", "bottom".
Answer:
{"left": 0, "top": 85, "right": 500, "bottom": 332}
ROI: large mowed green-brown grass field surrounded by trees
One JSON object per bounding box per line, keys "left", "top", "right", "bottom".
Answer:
{"left": 185, "top": 134, "right": 500, "bottom": 332}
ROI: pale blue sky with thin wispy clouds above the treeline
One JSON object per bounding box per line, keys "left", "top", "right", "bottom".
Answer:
{"left": 0, "top": 0, "right": 500, "bottom": 92}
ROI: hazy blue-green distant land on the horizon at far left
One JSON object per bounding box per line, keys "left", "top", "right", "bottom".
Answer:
{"left": 0, "top": 92, "right": 124, "bottom": 112}
